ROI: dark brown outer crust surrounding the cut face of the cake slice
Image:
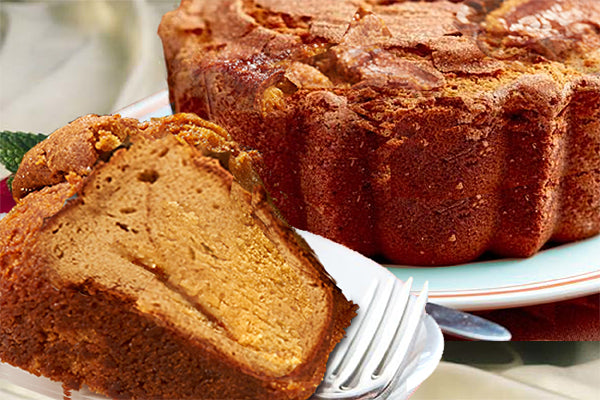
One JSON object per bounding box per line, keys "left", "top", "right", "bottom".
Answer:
{"left": 0, "top": 115, "right": 356, "bottom": 399}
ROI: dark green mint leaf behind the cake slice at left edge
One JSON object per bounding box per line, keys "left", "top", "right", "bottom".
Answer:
{"left": 0, "top": 131, "right": 47, "bottom": 190}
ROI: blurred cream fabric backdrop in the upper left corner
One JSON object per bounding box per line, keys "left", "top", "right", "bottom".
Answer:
{"left": 0, "top": 0, "right": 179, "bottom": 133}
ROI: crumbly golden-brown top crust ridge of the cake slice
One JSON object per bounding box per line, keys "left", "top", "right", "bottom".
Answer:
{"left": 12, "top": 113, "right": 261, "bottom": 201}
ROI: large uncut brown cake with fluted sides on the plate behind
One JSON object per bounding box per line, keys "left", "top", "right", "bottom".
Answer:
{"left": 159, "top": 0, "right": 600, "bottom": 265}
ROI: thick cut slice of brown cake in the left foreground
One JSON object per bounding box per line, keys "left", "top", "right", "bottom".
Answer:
{"left": 0, "top": 115, "right": 355, "bottom": 399}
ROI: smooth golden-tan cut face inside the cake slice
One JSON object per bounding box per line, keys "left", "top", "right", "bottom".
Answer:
{"left": 38, "top": 135, "right": 331, "bottom": 377}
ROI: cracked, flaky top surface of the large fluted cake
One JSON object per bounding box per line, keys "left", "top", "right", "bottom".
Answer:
{"left": 161, "top": 0, "right": 600, "bottom": 94}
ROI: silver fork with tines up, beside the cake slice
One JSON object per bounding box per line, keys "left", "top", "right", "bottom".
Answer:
{"left": 311, "top": 278, "right": 428, "bottom": 400}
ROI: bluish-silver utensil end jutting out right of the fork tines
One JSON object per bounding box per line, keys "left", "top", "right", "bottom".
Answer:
{"left": 425, "top": 303, "right": 511, "bottom": 342}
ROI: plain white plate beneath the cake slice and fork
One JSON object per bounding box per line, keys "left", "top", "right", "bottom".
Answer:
{"left": 0, "top": 228, "right": 444, "bottom": 400}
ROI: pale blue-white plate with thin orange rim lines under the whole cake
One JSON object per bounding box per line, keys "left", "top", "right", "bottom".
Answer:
{"left": 121, "top": 90, "right": 600, "bottom": 311}
